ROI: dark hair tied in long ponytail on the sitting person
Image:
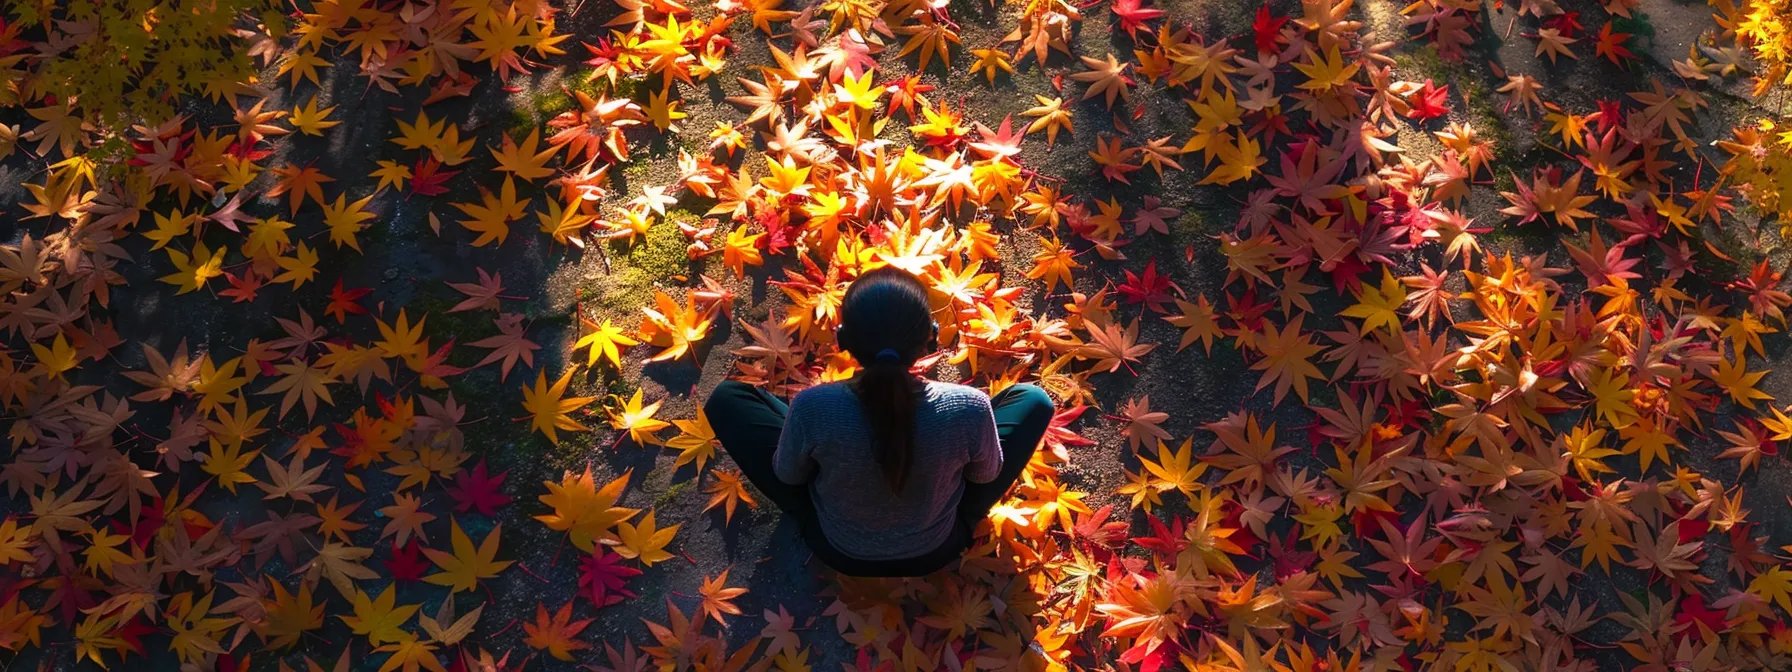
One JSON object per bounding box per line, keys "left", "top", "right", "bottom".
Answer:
{"left": 837, "top": 265, "right": 937, "bottom": 491}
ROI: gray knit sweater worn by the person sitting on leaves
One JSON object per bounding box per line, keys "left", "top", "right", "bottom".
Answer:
{"left": 772, "top": 382, "right": 1002, "bottom": 561}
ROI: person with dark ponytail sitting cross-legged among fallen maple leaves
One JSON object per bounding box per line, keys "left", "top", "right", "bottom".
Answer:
{"left": 704, "top": 267, "right": 1054, "bottom": 577}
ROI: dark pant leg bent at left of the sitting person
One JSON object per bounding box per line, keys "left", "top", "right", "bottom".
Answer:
{"left": 702, "top": 380, "right": 815, "bottom": 521}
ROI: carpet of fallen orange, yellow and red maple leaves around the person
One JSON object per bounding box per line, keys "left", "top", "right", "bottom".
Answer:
{"left": 0, "top": 0, "right": 1792, "bottom": 672}
